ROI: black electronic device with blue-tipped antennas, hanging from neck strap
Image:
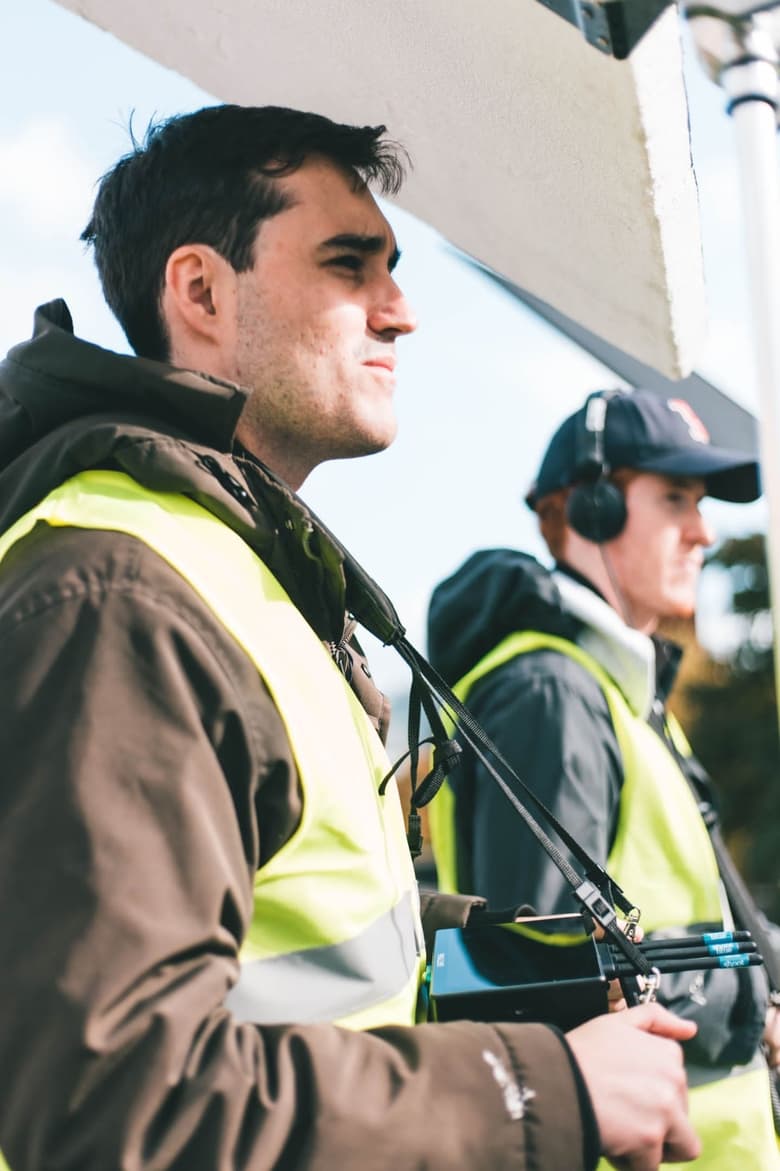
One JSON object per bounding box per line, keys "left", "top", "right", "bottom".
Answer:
{"left": 429, "top": 915, "right": 761, "bottom": 1029}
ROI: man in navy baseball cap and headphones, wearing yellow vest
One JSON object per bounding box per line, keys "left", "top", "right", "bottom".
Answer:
{"left": 429, "top": 390, "right": 780, "bottom": 1171}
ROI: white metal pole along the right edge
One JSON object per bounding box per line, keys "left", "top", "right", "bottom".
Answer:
{"left": 687, "top": 5, "right": 780, "bottom": 720}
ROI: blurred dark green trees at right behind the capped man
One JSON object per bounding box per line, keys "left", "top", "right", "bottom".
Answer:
{"left": 683, "top": 534, "right": 780, "bottom": 922}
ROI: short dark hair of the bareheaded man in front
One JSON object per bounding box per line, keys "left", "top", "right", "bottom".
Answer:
{"left": 81, "top": 105, "right": 405, "bottom": 361}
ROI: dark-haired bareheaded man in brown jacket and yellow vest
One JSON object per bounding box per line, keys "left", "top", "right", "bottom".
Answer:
{"left": 0, "top": 107, "right": 697, "bottom": 1171}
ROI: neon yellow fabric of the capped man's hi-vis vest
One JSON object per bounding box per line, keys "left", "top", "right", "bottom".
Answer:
{"left": 429, "top": 631, "right": 780, "bottom": 1171}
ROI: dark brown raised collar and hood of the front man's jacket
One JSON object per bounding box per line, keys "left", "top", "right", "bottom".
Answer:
{"left": 0, "top": 301, "right": 347, "bottom": 641}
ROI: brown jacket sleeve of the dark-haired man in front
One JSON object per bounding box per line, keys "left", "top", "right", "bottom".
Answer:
{"left": 0, "top": 529, "right": 594, "bottom": 1171}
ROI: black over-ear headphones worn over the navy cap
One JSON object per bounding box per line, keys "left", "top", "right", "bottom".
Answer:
{"left": 566, "top": 390, "right": 627, "bottom": 545}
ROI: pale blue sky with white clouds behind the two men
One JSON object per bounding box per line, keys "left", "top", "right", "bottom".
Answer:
{"left": 0, "top": 0, "right": 765, "bottom": 690}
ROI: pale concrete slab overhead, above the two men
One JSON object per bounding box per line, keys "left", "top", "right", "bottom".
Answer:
{"left": 51, "top": 0, "right": 705, "bottom": 377}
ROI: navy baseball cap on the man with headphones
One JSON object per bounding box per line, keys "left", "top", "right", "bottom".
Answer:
{"left": 526, "top": 390, "right": 761, "bottom": 508}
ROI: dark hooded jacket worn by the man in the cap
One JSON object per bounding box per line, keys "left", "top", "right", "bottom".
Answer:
{"left": 429, "top": 549, "right": 767, "bottom": 1066}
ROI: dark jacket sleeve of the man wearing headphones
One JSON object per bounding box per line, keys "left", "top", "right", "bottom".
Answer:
{"left": 461, "top": 650, "right": 622, "bottom": 915}
